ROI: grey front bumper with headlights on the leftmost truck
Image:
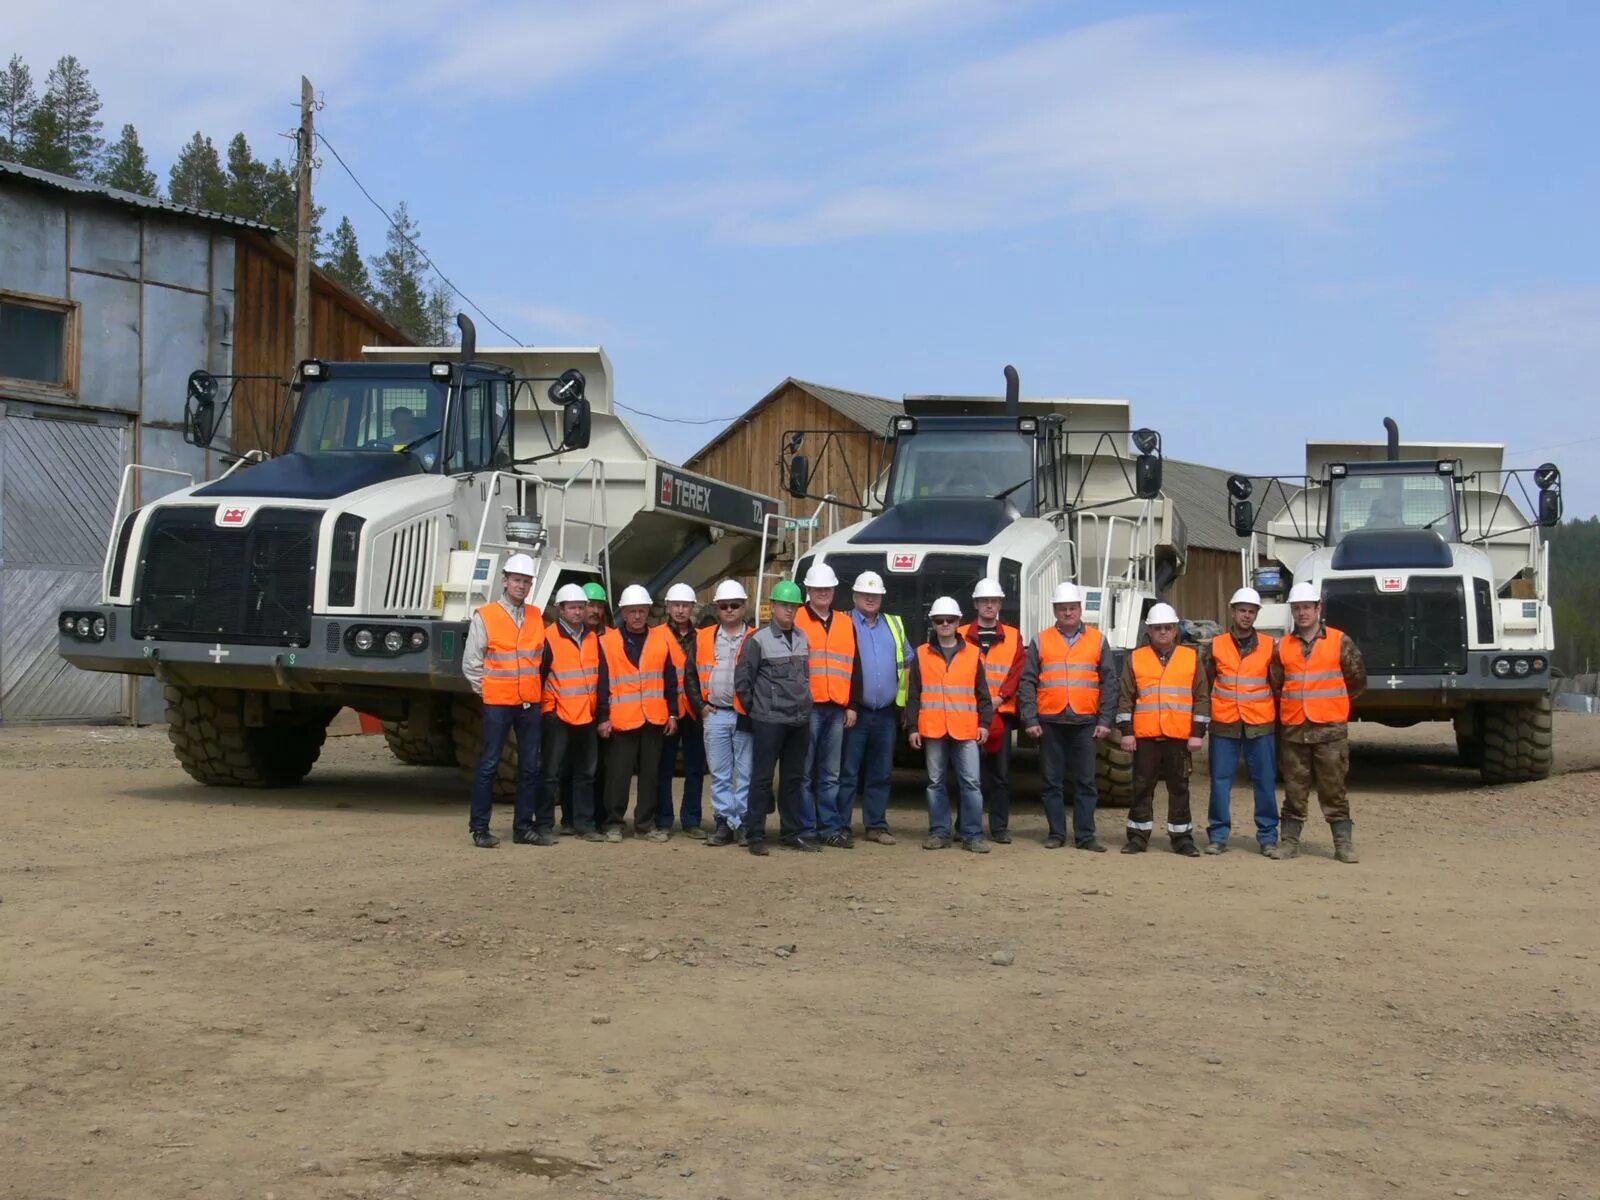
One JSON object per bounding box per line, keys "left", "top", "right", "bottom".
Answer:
{"left": 56, "top": 605, "right": 470, "bottom": 694}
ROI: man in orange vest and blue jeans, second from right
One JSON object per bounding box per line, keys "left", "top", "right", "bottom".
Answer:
{"left": 1200, "top": 587, "right": 1283, "bottom": 858}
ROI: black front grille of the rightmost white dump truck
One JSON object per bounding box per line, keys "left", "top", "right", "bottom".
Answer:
{"left": 1322, "top": 576, "right": 1467, "bottom": 675}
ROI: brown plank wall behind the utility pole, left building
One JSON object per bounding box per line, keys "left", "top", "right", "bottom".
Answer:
{"left": 234, "top": 234, "right": 410, "bottom": 453}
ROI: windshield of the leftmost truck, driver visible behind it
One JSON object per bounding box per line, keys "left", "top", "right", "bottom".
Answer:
{"left": 290, "top": 378, "right": 445, "bottom": 469}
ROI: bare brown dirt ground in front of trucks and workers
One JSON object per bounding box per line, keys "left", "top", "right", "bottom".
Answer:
{"left": 0, "top": 714, "right": 1600, "bottom": 1200}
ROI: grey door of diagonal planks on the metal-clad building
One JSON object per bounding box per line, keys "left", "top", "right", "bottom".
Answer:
{"left": 0, "top": 403, "right": 128, "bottom": 723}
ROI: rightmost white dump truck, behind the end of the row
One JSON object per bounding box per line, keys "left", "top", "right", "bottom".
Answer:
{"left": 1227, "top": 419, "right": 1562, "bottom": 784}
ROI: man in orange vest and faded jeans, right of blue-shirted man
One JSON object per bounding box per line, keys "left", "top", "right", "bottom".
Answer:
{"left": 906, "top": 595, "right": 995, "bottom": 854}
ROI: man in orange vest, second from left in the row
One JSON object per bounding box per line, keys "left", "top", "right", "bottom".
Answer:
{"left": 534, "top": 584, "right": 605, "bottom": 842}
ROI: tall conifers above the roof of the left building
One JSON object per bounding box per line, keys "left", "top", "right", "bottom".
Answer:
{"left": 0, "top": 54, "right": 456, "bottom": 346}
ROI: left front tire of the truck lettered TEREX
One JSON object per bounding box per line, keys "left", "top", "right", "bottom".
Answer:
{"left": 166, "top": 685, "right": 334, "bottom": 787}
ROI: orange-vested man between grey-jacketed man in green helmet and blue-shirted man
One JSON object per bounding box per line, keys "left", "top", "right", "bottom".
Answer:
{"left": 795, "top": 563, "right": 861, "bottom": 842}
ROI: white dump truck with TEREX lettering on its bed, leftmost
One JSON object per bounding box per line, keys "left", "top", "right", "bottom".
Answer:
{"left": 59, "top": 317, "right": 781, "bottom": 787}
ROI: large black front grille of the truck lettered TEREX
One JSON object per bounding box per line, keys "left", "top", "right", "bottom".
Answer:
{"left": 133, "top": 507, "right": 322, "bottom": 646}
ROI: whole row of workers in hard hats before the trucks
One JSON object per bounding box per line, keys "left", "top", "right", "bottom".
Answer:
{"left": 462, "top": 554, "right": 1366, "bottom": 862}
